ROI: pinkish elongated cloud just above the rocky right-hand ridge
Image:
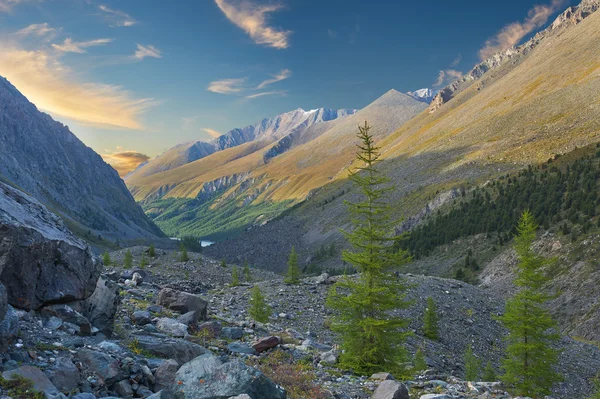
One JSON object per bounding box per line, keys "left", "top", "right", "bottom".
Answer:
{"left": 479, "top": 0, "right": 565, "bottom": 61}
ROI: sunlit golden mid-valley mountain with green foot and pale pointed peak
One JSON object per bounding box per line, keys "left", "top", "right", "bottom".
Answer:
{"left": 127, "top": 90, "right": 427, "bottom": 238}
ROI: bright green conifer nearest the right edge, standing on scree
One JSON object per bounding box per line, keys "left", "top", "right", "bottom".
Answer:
{"left": 499, "top": 211, "right": 561, "bottom": 398}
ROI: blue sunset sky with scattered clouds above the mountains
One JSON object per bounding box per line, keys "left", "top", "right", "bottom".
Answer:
{"left": 0, "top": 0, "right": 575, "bottom": 174}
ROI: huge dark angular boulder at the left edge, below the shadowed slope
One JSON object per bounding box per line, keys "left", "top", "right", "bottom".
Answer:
{"left": 0, "top": 182, "right": 102, "bottom": 310}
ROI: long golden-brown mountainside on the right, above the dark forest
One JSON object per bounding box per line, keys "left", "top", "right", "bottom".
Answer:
{"left": 207, "top": 0, "right": 600, "bottom": 270}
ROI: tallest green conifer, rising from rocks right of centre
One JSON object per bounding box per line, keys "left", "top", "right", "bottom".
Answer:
{"left": 327, "top": 122, "right": 410, "bottom": 375}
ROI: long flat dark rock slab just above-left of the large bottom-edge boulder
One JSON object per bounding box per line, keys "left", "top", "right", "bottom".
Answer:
{"left": 134, "top": 334, "right": 210, "bottom": 365}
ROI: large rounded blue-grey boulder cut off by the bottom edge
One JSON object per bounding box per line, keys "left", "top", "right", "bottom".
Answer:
{"left": 172, "top": 355, "right": 286, "bottom": 399}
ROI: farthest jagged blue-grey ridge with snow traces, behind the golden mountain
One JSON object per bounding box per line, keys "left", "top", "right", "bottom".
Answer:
{"left": 125, "top": 108, "right": 356, "bottom": 180}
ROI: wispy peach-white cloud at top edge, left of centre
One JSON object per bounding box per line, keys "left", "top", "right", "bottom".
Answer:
{"left": 215, "top": 0, "right": 292, "bottom": 49}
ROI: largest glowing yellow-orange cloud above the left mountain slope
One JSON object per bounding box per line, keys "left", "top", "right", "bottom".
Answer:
{"left": 0, "top": 45, "right": 156, "bottom": 129}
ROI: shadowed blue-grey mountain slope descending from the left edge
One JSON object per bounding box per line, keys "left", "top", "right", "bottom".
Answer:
{"left": 0, "top": 78, "right": 163, "bottom": 241}
